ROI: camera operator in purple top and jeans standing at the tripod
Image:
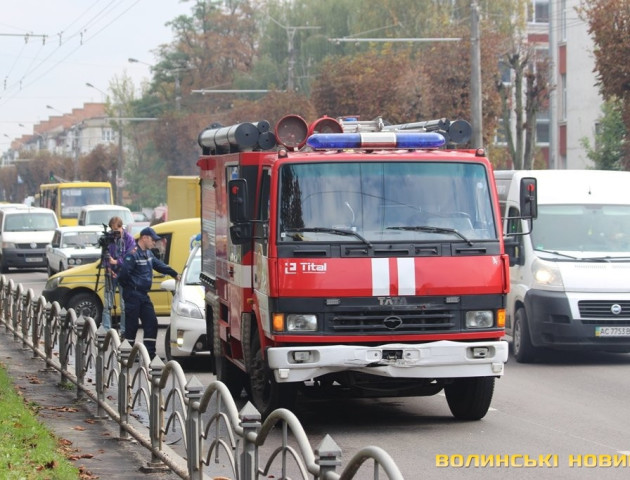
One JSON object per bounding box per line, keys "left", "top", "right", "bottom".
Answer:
{"left": 100, "top": 217, "right": 136, "bottom": 336}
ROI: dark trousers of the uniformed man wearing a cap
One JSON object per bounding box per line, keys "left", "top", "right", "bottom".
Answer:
{"left": 123, "top": 288, "right": 158, "bottom": 359}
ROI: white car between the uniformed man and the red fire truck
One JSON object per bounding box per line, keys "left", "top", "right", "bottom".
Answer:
{"left": 161, "top": 246, "right": 210, "bottom": 365}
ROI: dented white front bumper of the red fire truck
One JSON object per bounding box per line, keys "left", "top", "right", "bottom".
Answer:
{"left": 267, "top": 340, "right": 508, "bottom": 382}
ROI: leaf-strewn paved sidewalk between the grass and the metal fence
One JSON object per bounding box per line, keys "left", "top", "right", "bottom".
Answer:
{"left": 0, "top": 334, "right": 179, "bottom": 480}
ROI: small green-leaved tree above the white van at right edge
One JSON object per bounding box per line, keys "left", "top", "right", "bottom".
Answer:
{"left": 580, "top": 98, "right": 628, "bottom": 170}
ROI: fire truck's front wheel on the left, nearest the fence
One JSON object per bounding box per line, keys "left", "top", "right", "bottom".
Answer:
{"left": 249, "top": 332, "right": 297, "bottom": 418}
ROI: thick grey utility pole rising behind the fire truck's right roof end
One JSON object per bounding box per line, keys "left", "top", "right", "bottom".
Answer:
{"left": 470, "top": 0, "right": 483, "bottom": 148}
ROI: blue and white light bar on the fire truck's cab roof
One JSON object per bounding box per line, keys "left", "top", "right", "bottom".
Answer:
{"left": 306, "top": 132, "right": 446, "bottom": 150}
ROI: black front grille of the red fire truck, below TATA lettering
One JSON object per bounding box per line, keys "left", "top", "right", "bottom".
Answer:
{"left": 331, "top": 310, "right": 455, "bottom": 333}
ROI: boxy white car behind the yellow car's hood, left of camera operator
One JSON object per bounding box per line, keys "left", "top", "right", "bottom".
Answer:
{"left": 46, "top": 226, "right": 103, "bottom": 277}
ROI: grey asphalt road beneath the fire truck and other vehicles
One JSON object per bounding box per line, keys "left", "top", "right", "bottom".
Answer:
{"left": 9, "top": 272, "right": 630, "bottom": 480}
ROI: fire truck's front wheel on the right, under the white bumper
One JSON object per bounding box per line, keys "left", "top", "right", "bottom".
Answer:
{"left": 444, "top": 377, "right": 494, "bottom": 420}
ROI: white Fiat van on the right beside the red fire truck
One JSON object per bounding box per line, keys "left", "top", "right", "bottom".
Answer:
{"left": 495, "top": 170, "right": 630, "bottom": 362}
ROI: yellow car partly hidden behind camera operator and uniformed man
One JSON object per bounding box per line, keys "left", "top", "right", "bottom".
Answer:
{"left": 42, "top": 218, "right": 201, "bottom": 325}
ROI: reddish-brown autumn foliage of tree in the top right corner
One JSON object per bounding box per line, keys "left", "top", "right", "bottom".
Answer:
{"left": 579, "top": 0, "right": 630, "bottom": 169}
